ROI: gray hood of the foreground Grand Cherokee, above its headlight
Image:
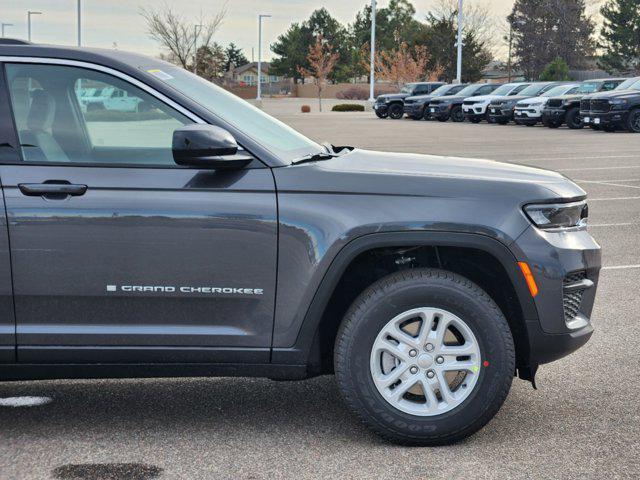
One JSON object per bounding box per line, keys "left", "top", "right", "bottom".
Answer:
{"left": 285, "top": 149, "right": 585, "bottom": 204}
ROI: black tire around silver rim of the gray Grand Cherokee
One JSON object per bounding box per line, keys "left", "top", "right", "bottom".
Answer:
{"left": 334, "top": 269, "right": 515, "bottom": 446}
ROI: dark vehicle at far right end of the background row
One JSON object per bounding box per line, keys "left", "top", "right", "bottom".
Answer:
{"left": 580, "top": 77, "right": 640, "bottom": 133}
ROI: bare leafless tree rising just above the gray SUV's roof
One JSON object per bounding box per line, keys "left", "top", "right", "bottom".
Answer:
{"left": 140, "top": 2, "right": 227, "bottom": 68}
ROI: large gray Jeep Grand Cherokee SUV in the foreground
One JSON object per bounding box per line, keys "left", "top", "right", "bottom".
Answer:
{"left": 0, "top": 43, "right": 600, "bottom": 445}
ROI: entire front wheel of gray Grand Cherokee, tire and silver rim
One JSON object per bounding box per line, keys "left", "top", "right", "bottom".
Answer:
{"left": 334, "top": 269, "right": 515, "bottom": 445}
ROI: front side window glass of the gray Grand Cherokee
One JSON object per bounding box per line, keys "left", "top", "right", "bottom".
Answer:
{"left": 6, "top": 64, "right": 192, "bottom": 166}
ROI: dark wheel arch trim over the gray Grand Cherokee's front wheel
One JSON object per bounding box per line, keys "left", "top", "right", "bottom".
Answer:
{"left": 271, "top": 231, "right": 539, "bottom": 364}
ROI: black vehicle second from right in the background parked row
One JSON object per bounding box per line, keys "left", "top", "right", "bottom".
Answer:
{"left": 542, "top": 78, "right": 625, "bottom": 129}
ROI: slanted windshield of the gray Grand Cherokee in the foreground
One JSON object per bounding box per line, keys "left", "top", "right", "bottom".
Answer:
{"left": 144, "top": 65, "right": 326, "bottom": 162}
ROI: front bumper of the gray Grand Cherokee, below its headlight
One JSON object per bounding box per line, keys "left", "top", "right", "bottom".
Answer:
{"left": 516, "top": 226, "right": 601, "bottom": 365}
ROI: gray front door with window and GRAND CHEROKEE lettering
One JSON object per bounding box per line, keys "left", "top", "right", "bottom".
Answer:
{"left": 0, "top": 63, "right": 277, "bottom": 362}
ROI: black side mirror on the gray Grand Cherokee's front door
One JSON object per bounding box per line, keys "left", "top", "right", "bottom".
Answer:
{"left": 172, "top": 123, "right": 253, "bottom": 169}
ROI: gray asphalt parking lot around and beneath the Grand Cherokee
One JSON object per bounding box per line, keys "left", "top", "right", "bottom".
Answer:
{"left": 0, "top": 101, "right": 640, "bottom": 480}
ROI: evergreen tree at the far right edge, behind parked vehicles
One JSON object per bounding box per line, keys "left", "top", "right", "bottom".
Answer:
{"left": 598, "top": 0, "right": 640, "bottom": 74}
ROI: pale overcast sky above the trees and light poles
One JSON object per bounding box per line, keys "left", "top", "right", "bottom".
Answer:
{"left": 0, "top": 0, "right": 600, "bottom": 60}
